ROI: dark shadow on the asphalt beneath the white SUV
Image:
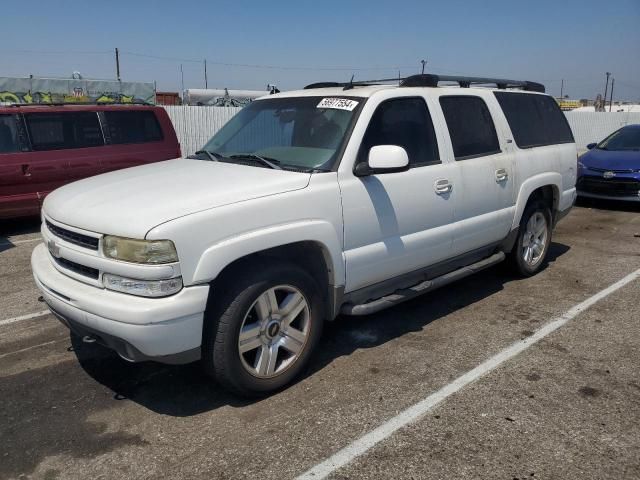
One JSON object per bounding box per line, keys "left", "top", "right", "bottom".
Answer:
{"left": 71, "top": 242, "right": 570, "bottom": 417}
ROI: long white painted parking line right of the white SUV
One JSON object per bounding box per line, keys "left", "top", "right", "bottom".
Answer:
{"left": 297, "top": 269, "right": 640, "bottom": 480}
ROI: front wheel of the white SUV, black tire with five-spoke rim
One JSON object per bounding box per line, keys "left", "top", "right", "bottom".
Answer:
{"left": 202, "top": 263, "right": 325, "bottom": 397}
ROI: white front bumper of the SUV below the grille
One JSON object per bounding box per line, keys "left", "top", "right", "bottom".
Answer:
{"left": 31, "top": 244, "right": 209, "bottom": 363}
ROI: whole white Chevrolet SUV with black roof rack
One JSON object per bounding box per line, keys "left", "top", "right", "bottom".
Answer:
{"left": 32, "top": 75, "right": 577, "bottom": 395}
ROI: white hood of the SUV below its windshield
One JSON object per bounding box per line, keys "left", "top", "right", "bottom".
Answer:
{"left": 43, "top": 159, "right": 311, "bottom": 238}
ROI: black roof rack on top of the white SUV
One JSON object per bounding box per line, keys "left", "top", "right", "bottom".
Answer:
{"left": 304, "top": 73, "right": 545, "bottom": 93}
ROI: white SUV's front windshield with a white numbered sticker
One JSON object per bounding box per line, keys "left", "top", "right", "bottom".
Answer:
{"left": 202, "top": 97, "right": 364, "bottom": 171}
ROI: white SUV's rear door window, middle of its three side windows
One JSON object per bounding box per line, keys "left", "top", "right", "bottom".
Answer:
{"left": 440, "top": 96, "right": 500, "bottom": 160}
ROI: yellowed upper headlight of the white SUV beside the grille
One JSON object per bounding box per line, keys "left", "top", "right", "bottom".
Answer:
{"left": 102, "top": 235, "right": 178, "bottom": 265}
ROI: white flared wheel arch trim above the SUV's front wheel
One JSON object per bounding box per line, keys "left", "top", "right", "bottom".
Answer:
{"left": 193, "top": 220, "right": 345, "bottom": 286}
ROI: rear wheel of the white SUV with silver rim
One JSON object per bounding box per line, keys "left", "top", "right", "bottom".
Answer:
{"left": 509, "top": 200, "right": 552, "bottom": 277}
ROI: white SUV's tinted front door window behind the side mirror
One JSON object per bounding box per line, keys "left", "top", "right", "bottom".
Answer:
{"left": 358, "top": 98, "right": 441, "bottom": 167}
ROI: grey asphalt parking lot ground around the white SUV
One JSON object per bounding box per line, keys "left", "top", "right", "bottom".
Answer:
{"left": 0, "top": 203, "right": 640, "bottom": 480}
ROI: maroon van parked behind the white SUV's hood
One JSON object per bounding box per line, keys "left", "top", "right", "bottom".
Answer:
{"left": 0, "top": 105, "right": 180, "bottom": 219}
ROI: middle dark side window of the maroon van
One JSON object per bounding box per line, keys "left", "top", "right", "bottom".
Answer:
{"left": 24, "top": 112, "right": 104, "bottom": 151}
